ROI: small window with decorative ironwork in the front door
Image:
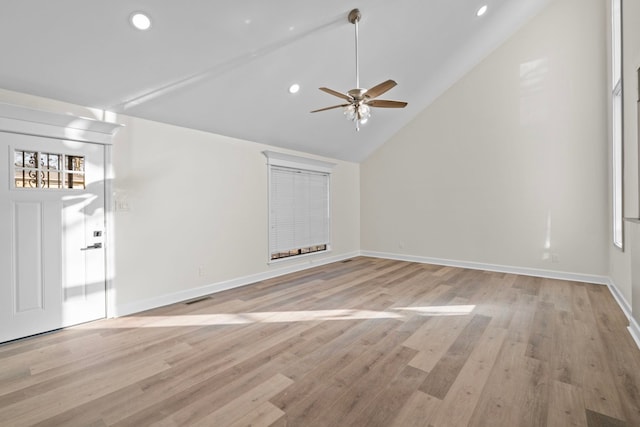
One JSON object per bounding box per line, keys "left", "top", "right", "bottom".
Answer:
{"left": 13, "top": 150, "right": 85, "bottom": 189}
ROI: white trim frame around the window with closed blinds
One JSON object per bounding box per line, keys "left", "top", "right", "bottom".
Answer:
{"left": 262, "top": 150, "right": 336, "bottom": 264}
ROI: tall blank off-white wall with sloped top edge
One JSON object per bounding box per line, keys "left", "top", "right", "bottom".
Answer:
{"left": 361, "top": 0, "right": 609, "bottom": 276}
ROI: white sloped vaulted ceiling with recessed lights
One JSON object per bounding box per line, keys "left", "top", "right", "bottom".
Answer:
{"left": 0, "top": 0, "right": 551, "bottom": 162}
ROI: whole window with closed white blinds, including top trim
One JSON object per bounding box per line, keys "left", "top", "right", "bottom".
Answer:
{"left": 264, "top": 151, "right": 333, "bottom": 261}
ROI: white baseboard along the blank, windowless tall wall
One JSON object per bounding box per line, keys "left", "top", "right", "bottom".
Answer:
{"left": 361, "top": 251, "right": 610, "bottom": 285}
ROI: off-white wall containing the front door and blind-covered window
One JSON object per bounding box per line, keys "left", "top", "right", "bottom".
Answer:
{"left": 0, "top": 90, "right": 360, "bottom": 314}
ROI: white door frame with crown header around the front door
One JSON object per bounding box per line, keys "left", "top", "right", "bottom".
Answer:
{"left": 0, "top": 102, "right": 123, "bottom": 318}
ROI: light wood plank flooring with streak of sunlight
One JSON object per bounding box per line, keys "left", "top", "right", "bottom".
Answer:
{"left": 0, "top": 257, "right": 640, "bottom": 427}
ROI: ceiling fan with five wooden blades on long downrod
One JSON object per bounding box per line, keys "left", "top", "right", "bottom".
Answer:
{"left": 312, "top": 9, "right": 407, "bottom": 131}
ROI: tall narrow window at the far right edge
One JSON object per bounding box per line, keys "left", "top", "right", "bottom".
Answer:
{"left": 611, "top": 0, "right": 624, "bottom": 248}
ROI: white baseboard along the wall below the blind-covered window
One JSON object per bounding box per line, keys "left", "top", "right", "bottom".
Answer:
{"left": 113, "top": 251, "right": 360, "bottom": 317}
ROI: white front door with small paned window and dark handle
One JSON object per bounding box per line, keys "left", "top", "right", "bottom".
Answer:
{"left": 0, "top": 132, "right": 106, "bottom": 342}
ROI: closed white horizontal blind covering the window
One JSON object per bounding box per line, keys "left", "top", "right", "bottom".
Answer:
{"left": 269, "top": 166, "right": 329, "bottom": 254}
